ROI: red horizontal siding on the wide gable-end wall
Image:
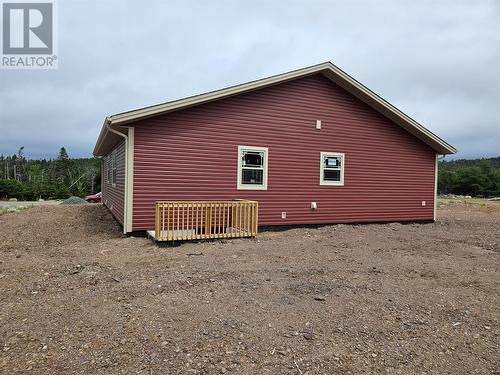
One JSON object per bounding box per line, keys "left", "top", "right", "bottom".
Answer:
{"left": 133, "top": 74, "right": 435, "bottom": 230}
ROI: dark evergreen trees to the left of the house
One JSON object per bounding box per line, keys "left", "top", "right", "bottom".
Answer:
{"left": 0, "top": 147, "right": 101, "bottom": 200}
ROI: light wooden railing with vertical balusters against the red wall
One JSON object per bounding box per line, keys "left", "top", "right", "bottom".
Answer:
{"left": 155, "top": 200, "right": 259, "bottom": 241}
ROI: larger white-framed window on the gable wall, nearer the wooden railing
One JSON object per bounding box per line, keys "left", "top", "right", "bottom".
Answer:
{"left": 237, "top": 146, "right": 269, "bottom": 190}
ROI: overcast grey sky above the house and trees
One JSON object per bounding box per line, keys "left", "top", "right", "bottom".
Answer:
{"left": 0, "top": 0, "right": 500, "bottom": 158}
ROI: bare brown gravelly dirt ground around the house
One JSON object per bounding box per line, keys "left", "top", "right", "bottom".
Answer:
{"left": 0, "top": 204, "right": 500, "bottom": 375}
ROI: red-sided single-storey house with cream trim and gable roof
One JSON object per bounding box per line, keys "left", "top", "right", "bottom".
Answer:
{"left": 94, "top": 62, "right": 456, "bottom": 236}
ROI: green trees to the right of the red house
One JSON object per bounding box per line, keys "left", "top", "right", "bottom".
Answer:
{"left": 438, "top": 157, "right": 500, "bottom": 197}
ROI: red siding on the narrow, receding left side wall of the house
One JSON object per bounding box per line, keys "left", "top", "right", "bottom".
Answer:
{"left": 102, "top": 141, "right": 125, "bottom": 225}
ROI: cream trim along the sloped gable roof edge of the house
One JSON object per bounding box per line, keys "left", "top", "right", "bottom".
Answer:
{"left": 94, "top": 61, "right": 457, "bottom": 156}
